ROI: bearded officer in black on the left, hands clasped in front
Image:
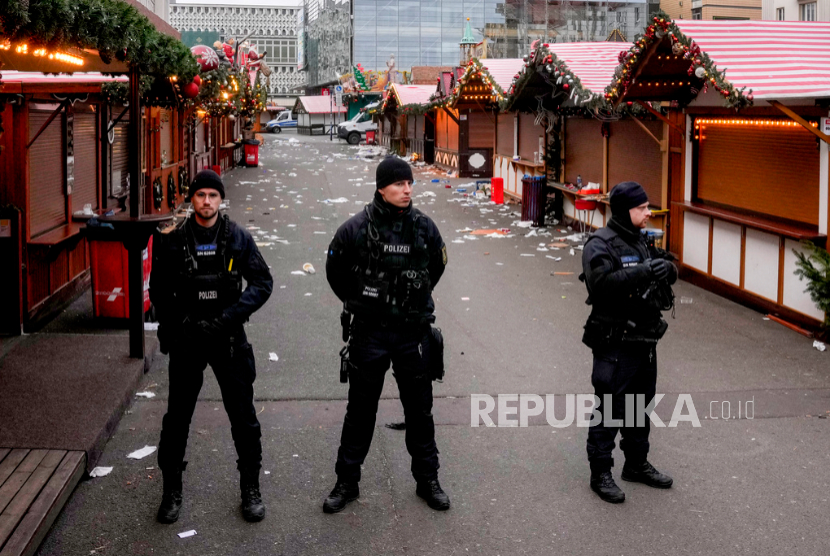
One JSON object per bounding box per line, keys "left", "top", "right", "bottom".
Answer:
{"left": 150, "top": 170, "right": 273, "bottom": 523}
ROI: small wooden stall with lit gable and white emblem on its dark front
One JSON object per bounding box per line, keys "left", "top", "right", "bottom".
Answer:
{"left": 435, "top": 57, "right": 523, "bottom": 178}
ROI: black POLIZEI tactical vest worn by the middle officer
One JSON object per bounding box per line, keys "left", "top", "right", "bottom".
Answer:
{"left": 346, "top": 206, "right": 432, "bottom": 320}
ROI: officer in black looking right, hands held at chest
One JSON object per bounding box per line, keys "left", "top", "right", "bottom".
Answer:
{"left": 580, "top": 182, "right": 677, "bottom": 503}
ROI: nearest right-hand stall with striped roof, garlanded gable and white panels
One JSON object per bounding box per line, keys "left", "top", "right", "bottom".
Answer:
{"left": 606, "top": 14, "right": 830, "bottom": 327}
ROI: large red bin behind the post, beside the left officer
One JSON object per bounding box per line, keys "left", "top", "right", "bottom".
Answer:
{"left": 85, "top": 228, "right": 153, "bottom": 319}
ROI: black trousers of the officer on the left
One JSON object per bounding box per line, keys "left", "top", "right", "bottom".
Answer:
{"left": 159, "top": 332, "right": 262, "bottom": 472}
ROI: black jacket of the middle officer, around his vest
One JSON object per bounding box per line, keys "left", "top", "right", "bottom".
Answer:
{"left": 326, "top": 193, "right": 447, "bottom": 321}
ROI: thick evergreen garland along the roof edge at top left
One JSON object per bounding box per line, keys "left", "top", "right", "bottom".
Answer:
{"left": 0, "top": 0, "right": 199, "bottom": 83}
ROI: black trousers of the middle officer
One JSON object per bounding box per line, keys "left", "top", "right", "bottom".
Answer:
{"left": 335, "top": 322, "right": 439, "bottom": 482}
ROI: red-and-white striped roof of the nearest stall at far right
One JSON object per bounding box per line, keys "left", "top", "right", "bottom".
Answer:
{"left": 680, "top": 19, "right": 830, "bottom": 99}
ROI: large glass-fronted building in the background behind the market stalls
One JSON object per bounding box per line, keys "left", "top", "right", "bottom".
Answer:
{"left": 304, "top": 0, "right": 660, "bottom": 87}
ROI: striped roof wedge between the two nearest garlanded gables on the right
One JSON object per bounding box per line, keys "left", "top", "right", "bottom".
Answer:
{"left": 545, "top": 42, "right": 632, "bottom": 94}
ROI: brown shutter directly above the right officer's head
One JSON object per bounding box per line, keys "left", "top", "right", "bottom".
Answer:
{"left": 604, "top": 120, "right": 663, "bottom": 206}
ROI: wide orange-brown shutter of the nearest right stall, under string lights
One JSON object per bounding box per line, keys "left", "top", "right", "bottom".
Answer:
{"left": 696, "top": 124, "right": 821, "bottom": 226}
